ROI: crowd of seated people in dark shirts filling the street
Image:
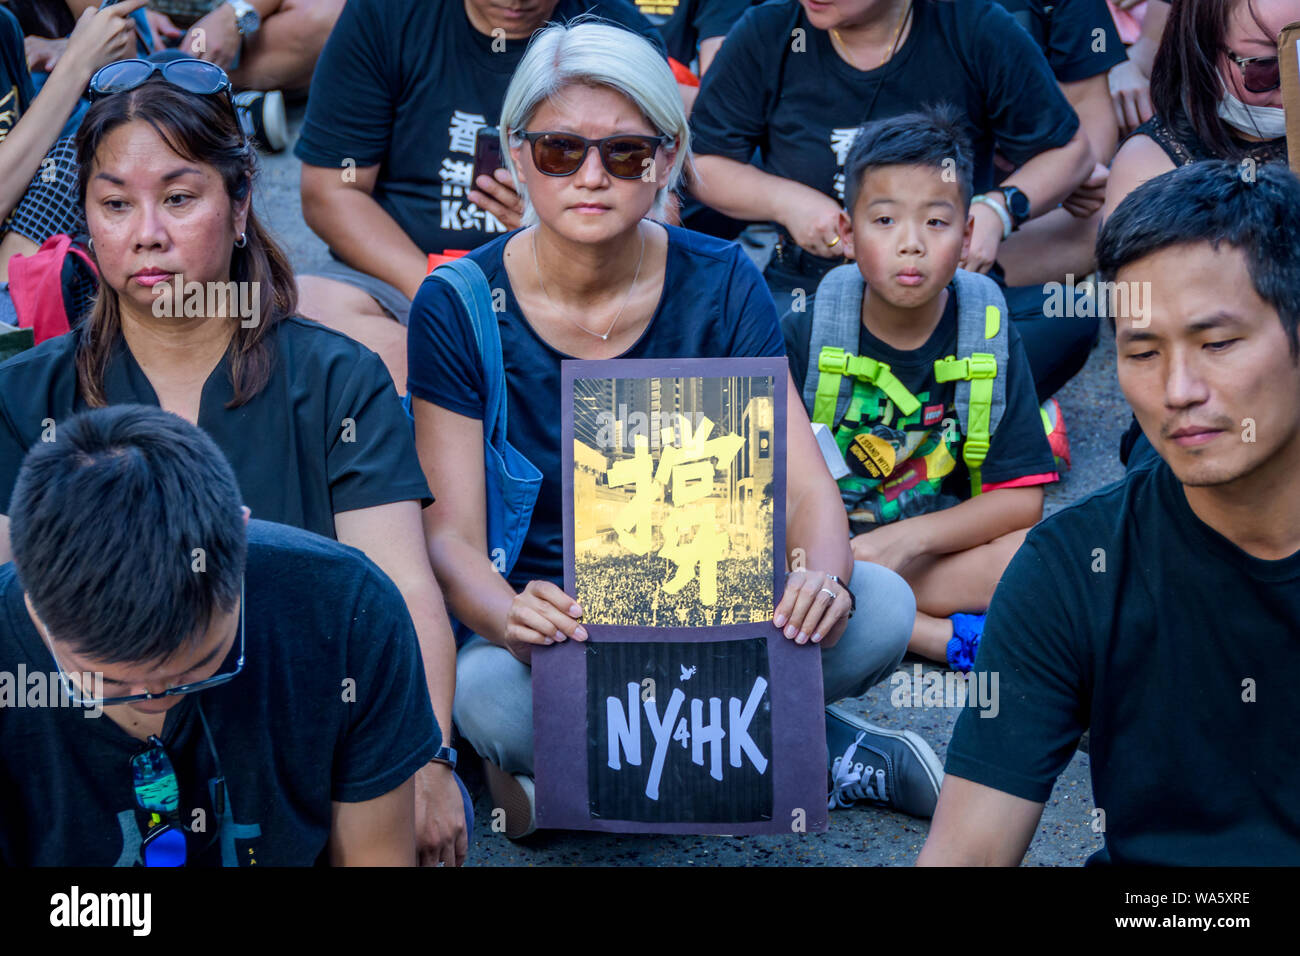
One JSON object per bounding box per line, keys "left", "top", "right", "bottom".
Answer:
{"left": 0, "top": 0, "right": 1300, "bottom": 866}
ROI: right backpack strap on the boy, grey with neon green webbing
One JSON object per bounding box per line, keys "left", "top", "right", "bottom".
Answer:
{"left": 935, "top": 269, "right": 1010, "bottom": 496}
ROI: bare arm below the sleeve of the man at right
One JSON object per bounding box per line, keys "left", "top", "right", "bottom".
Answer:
{"left": 917, "top": 774, "right": 1043, "bottom": 866}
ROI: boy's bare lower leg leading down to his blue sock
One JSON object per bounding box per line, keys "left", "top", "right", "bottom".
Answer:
{"left": 902, "top": 529, "right": 1028, "bottom": 663}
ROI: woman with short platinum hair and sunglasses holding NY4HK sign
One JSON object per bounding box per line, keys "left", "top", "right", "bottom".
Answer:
{"left": 408, "top": 23, "right": 941, "bottom": 836}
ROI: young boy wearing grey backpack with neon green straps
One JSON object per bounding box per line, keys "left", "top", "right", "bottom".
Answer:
{"left": 781, "top": 109, "right": 1057, "bottom": 670}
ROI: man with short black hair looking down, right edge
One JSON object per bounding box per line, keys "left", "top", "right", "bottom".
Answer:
{"left": 919, "top": 161, "right": 1300, "bottom": 865}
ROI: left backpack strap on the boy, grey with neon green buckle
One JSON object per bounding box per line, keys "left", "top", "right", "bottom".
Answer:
{"left": 803, "top": 263, "right": 866, "bottom": 429}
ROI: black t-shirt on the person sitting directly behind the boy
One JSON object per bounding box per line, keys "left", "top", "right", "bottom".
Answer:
{"left": 690, "top": 0, "right": 1079, "bottom": 203}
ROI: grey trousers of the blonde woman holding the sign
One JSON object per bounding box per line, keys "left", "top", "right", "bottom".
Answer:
{"left": 452, "top": 561, "right": 917, "bottom": 777}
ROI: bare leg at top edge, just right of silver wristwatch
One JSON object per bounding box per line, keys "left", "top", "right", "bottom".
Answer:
{"left": 230, "top": 0, "right": 343, "bottom": 91}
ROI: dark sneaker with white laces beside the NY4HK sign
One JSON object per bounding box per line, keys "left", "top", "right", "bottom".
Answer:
{"left": 826, "top": 708, "right": 944, "bottom": 819}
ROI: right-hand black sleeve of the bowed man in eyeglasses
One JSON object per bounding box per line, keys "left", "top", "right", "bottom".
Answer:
{"left": 330, "top": 561, "right": 442, "bottom": 804}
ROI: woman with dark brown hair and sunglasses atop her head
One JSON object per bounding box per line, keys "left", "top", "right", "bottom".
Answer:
{"left": 0, "top": 59, "right": 467, "bottom": 865}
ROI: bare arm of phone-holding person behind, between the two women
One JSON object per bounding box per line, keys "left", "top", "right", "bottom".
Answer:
{"left": 302, "top": 163, "right": 428, "bottom": 299}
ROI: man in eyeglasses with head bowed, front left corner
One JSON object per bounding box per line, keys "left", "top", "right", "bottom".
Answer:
{"left": 0, "top": 406, "right": 446, "bottom": 866}
